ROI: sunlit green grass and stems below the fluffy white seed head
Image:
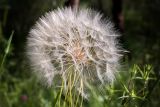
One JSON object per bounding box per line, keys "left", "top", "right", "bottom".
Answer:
{"left": 0, "top": 32, "right": 159, "bottom": 107}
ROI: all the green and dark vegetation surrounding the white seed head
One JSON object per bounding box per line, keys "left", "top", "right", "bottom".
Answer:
{"left": 0, "top": 0, "right": 160, "bottom": 107}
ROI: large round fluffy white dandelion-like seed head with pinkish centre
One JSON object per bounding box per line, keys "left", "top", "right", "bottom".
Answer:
{"left": 27, "top": 8, "right": 121, "bottom": 93}
